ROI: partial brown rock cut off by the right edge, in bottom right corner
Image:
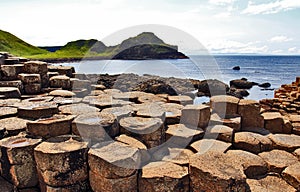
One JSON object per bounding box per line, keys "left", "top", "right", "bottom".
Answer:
{"left": 282, "top": 162, "right": 300, "bottom": 191}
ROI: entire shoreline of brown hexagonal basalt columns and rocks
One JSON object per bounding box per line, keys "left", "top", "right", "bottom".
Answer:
{"left": 0, "top": 53, "right": 300, "bottom": 192}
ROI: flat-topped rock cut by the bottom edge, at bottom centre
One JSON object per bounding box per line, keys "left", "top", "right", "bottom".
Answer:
{"left": 139, "top": 162, "right": 189, "bottom": 192}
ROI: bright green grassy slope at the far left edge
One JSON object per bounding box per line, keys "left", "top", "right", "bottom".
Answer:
{"left": 0, "top": 30, "right": 48, "bottom": 57}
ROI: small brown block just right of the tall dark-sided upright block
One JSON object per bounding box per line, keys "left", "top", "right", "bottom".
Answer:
{"left": 262, "top": 112, "right": 284, "bottom": 133}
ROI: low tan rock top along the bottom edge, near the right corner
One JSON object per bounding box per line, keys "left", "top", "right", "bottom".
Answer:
{"left": 247, "top": 175, "right": 296, "bottom": 192}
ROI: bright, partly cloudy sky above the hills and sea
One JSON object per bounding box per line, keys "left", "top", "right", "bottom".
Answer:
{"left": 0, "top": 0, "right": 300, "bottom": 55}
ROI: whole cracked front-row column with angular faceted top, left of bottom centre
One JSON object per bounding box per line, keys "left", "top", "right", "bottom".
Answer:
{"left": 88, "top": 142, "right": 140, "bottom": 192}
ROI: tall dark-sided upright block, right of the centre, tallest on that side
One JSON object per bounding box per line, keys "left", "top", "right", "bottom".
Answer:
{"left": 238, "top": 99, "right": 264, "bottom": 130}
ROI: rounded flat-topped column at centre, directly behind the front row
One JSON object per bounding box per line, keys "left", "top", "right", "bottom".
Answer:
{"left": 120, "top": 117, "right": 164, "bottom": 148}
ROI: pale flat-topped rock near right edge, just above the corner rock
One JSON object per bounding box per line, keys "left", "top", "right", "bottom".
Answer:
{"left": 258, "top": 149, "right": 298, "bottom": 173}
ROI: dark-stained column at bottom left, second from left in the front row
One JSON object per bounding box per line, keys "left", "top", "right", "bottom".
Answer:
{"left": 34, "top": 135, "right": 88, "bottom": 187}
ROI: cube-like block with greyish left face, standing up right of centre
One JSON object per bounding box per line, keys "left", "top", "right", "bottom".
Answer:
{"left": 180, "top": 105, "right": 210, "bottom": 129}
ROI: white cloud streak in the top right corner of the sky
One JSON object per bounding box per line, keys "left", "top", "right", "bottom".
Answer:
{"left": 242, "top": 0, "right": 300, "bottom": 15}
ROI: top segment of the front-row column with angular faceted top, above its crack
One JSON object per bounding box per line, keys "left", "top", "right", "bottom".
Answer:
{"left": 88, "top": 141, "right": 141, "bottom": 179}
